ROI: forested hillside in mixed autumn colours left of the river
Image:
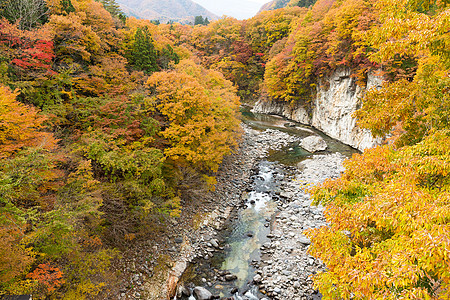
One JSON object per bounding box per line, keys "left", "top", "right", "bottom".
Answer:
{"left": 0, "top": 0, "right": 239, "bottom": 299}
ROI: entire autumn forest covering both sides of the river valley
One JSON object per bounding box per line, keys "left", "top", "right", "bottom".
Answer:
{"left": 0, "top": 0, "right": 450, "bottom": 299}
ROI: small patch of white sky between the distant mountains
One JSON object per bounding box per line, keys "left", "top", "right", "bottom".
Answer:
{"left": 192, "top": 0, "right": 270, "bottom": 20}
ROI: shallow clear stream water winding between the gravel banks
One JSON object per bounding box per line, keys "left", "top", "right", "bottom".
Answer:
{"left": 175, "top": 110, "right": 356, "bottom": 300}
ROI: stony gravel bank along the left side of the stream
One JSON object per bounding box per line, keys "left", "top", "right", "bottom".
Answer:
{"left": 114, "top": 124, "right": 304, "bottom": 300}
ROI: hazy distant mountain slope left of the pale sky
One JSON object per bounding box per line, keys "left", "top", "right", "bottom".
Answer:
{"left": 117, "top": 0, "right": 218, "bottom": 23}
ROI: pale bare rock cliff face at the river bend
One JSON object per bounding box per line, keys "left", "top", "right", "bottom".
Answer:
{"left": 253, "top": 69, "right": 382, "bottom": 150}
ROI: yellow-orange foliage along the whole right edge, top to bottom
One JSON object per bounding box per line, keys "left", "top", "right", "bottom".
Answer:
{"left": 308, "top": 0, "right": 450, "bottom": 299}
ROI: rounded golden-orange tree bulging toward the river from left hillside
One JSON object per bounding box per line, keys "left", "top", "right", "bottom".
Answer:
{"left": 147, "top": 60, "right": 239, "bottom": 171}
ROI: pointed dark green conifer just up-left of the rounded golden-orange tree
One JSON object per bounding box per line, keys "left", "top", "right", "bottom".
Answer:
{"left": 130, "top": 27, "right": 159, "bottom": 74}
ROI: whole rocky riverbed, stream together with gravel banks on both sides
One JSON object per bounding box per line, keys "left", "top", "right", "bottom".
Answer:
{"left": 137, "top": 109, "right": 357, "bottom": 300}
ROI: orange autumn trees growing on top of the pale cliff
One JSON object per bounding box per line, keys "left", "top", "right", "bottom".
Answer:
{"left": 264, "top": 0, "right": 377, "bottom": 103}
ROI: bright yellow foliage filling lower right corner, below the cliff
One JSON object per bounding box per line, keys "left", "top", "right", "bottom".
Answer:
{"left": 309, "top": 132, "right": 450, "bottom": 299}
